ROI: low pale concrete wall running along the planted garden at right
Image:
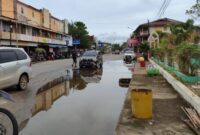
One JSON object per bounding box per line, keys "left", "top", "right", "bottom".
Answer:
{"left": 149, "top": 59, "right": 200, "bottom": 113}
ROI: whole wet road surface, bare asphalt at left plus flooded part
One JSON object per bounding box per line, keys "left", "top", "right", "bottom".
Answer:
{"left": 0, "top": 55, "right": 131, "bottom": 135}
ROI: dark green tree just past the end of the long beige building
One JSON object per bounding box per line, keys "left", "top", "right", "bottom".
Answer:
{"left": 69, "top": 21, "right": 91, "bottom": 49}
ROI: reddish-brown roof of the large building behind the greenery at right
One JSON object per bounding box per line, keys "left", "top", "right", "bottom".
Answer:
{"left": 135, "top": 18, "right": 183, "bottom": 31}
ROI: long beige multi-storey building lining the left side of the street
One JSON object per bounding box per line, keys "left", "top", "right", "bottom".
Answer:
{"left": 0, "top": 0, "right": 68, "bottom": 52}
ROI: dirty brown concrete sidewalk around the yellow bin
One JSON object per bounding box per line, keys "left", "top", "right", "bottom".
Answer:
{"left": 116, "top": 63, "right": 194, "bottom": 135}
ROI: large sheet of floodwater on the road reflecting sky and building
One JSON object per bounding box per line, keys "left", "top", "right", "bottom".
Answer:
{"left": 20, "top": 61, "right": 131, "bottom": 135}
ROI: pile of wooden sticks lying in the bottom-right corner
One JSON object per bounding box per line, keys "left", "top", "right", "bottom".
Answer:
{"left": 181, "top": 107, "right": 200, "bottom": 135}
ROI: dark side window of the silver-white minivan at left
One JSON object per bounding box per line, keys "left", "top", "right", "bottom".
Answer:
{"left": 0, "top": 51, "right": 17, "bottom": 64}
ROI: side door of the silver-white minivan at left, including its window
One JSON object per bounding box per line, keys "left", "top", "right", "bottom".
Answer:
{"left": 0, "top": 50, "right": 19, "bottom": 87}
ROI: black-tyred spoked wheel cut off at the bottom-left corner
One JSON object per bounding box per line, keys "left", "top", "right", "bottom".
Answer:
{"left": 0, "top": 108, "right": 18, "bottom": 135}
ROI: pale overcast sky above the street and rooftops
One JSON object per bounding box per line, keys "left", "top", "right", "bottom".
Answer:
{"left": 20, "top": 0, "right": 196, "bottom": 43}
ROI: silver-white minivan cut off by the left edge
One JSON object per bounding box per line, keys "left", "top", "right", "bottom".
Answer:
{"left": 0, "top": 47, "right": 31, "bottom": 90}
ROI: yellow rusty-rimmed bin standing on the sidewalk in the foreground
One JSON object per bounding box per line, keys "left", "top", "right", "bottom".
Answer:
{"left": 131, "top": 89, "right": 152, "bottom": 119}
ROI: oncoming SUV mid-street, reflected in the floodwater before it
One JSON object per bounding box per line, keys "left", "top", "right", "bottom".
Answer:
{"left": 79, "top": 50, "right": 103, "bottom": 68}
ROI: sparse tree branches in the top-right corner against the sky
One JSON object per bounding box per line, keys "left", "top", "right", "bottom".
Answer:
{"left": 186, "top": 0, "right": 200, "bottom": 20}
